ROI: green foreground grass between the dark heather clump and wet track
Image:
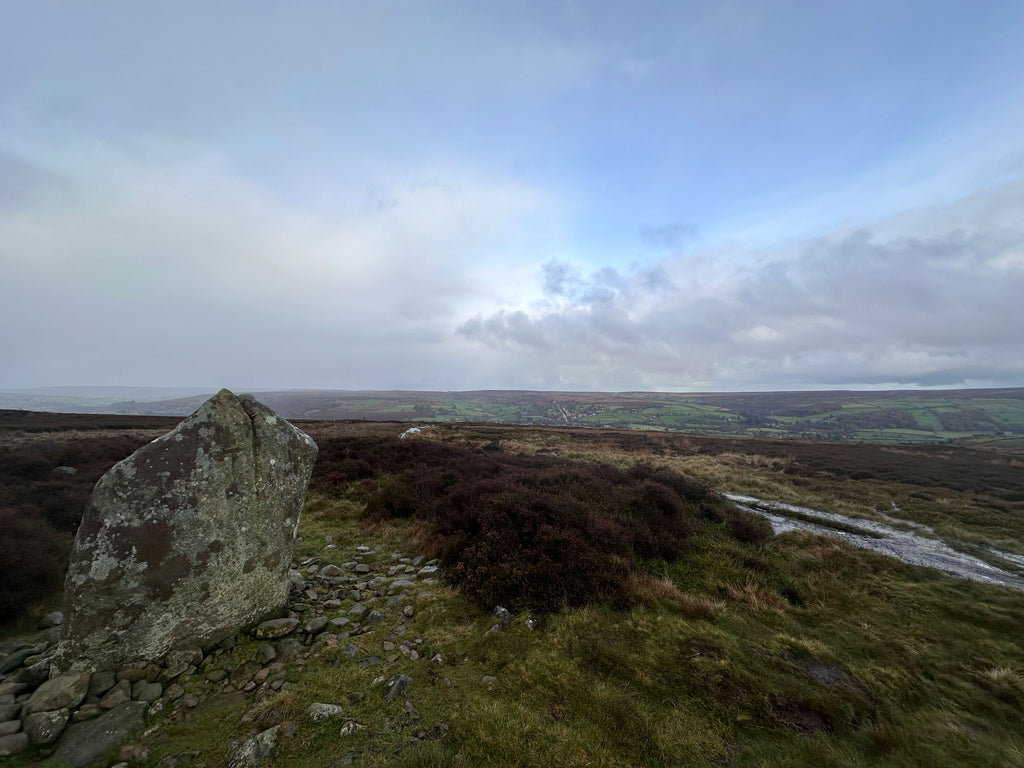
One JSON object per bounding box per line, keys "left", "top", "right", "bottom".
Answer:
{"left": 138, "top": 499, "right": 1024, "bottom": 768}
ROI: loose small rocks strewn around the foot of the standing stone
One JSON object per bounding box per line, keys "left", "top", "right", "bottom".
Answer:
{"left": 0, "top": 546, "right": 440, "bottom": 767}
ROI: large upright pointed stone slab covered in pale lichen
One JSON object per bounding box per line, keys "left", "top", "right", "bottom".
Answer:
{"left": 57, "top": 389, "right": 316, "bottom": 670}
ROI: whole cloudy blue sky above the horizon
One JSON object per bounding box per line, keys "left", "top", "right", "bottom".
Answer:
{"left": 0, "top": 0, "right": 1024, "bottom": 391}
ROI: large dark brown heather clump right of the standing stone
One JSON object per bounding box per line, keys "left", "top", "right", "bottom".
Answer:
{"left": 312, "top": 437, "right": 771, "bottom": 612}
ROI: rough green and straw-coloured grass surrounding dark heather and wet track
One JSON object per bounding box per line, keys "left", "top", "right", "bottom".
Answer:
{"left": 2, "top": 423, "right": 1024, "bottom": 767}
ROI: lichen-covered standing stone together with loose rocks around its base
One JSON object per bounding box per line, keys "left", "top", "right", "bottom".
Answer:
{"left": 0, "top": 389, "right": 327, "bottom": 766}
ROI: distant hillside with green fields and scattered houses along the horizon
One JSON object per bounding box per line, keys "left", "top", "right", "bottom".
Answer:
{"left": 0, "top": 388, "right": 1024, "bottom": 442}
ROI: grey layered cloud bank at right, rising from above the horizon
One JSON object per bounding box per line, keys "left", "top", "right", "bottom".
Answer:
{"left": 459, "top": 184, "right": 1024, "bottom": 388}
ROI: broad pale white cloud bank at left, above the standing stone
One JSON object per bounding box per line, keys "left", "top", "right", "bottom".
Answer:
{"left": 0, "top": 146, "right": 556, "bottom": 387}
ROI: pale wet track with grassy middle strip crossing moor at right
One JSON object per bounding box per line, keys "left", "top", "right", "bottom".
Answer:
{"left": 724, "top": 494, "right": 1024, "bottom": 592}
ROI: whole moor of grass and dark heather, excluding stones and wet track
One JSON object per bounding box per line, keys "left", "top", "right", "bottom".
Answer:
{"left": 0, "top": 411, "right": 1024, "bottom": 767}
